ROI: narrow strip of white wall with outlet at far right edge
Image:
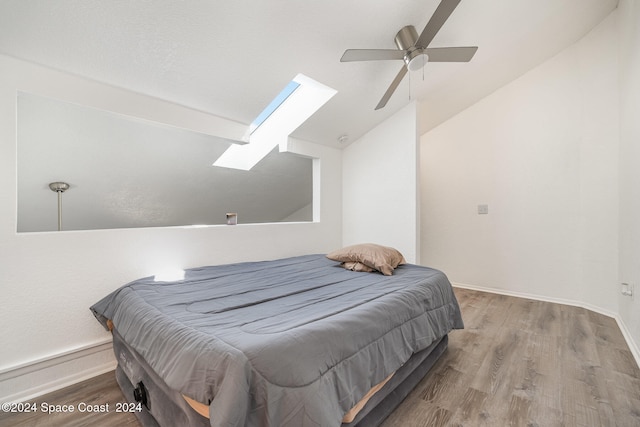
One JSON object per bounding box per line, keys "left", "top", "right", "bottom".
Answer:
{"left": 618, "top": 0, "right": 640, "bottom": 362}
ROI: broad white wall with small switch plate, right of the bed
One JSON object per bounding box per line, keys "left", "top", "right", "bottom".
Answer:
{"left": 421, "top": 13, "right": 620, "bottom": 314}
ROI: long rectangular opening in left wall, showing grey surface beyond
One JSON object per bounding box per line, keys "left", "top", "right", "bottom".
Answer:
{"left": 17, "top": 93, "right": 313, "bottom": 232}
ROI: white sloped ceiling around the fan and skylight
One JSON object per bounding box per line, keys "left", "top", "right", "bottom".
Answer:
{"left": 0, "top": 0, "right": 617, "bottom": 146}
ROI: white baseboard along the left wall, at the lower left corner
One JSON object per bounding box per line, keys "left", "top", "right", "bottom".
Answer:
{"left": 0, "top": 340, "right": 116, "bottom": 402}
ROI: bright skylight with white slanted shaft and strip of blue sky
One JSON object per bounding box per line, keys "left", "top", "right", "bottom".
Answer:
{"left": 213, "top": 74, "right": 337, "bottom": 170}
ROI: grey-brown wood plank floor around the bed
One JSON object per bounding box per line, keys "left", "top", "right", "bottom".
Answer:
{"left": 0, "top": 288, "right": 640, "bottom": 427}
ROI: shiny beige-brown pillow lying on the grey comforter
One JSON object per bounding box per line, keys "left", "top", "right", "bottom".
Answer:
{"left": 327, "top": 243, "right": 406, "bottom": 276}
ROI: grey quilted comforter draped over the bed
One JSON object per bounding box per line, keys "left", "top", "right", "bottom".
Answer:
{"left": 91, "top": 255, "right": 463, "bottom": 427}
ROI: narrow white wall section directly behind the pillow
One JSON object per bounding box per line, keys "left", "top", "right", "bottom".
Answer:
{"left": 342, "top": 102, "right": 419, "bottom": 263}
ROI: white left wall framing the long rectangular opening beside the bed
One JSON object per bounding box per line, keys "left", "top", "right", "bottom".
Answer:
{"left": 0, "top": 56, "right": 342, "bottom": 401}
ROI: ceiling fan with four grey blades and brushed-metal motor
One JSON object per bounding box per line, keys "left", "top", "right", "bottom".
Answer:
{"left": 340, "top": 0, "right": 478, "bottom": 110}
